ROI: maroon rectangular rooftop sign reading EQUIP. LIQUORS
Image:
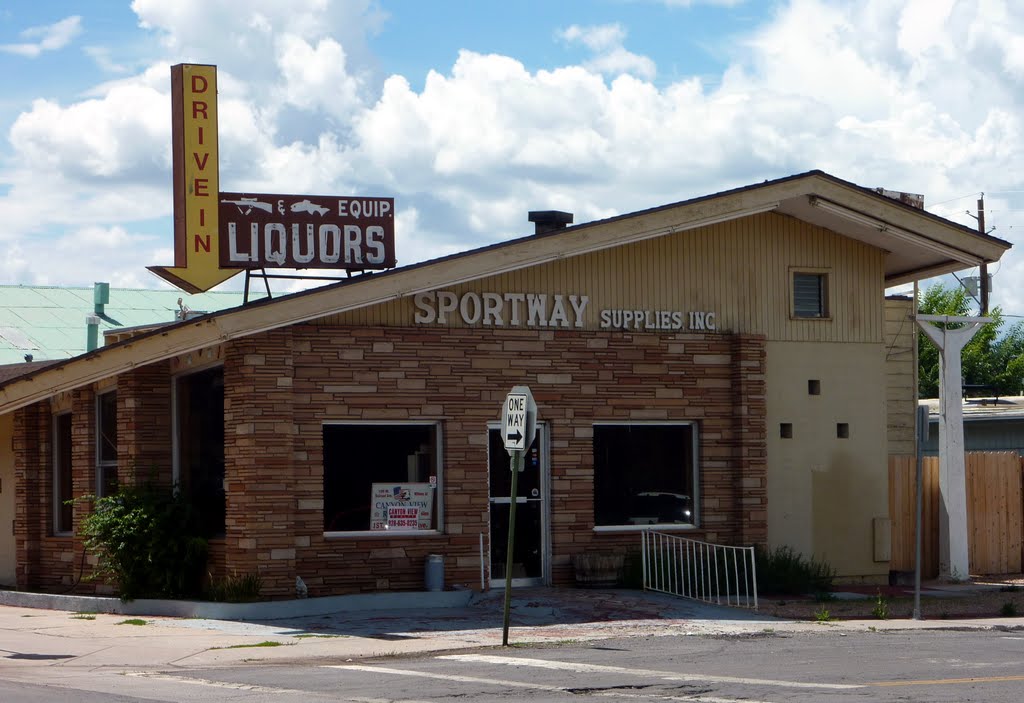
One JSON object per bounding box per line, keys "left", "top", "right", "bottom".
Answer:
{"left": 218, "top": 192, "right": 396, "bottom": 271}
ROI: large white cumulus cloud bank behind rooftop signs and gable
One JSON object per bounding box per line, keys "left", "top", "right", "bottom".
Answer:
{"left": 0, "top": 0, "right": 1024, "bottom": 312}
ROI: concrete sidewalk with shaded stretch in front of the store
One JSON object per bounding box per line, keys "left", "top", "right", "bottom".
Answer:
{"left": 0, "top": 588, "right": 1024, "bottom": 673}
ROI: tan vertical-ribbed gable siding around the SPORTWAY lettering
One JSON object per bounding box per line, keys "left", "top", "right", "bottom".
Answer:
{"left": 322, "top": 213, "right": 884, "bottom": 343}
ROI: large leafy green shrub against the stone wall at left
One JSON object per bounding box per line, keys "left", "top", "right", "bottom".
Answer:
{"left": 79, "top": 483, "right": 207, "bottom": 601}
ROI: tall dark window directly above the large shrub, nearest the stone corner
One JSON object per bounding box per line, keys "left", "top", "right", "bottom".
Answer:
{"left": 177, "top": 366, "right": 226, "bottom": 537}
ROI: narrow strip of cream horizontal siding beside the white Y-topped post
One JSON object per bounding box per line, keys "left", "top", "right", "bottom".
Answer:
{"left": 886, "top": 298, "right": 918, "bottom": 454}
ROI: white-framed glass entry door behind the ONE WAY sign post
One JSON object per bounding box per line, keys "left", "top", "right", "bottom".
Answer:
{"left": 487, "top": 423, "right": 550, "bottom": 588}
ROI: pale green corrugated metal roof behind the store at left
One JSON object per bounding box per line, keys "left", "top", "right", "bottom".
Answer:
{"left": 0, "top": 285, "right": 253, "bottom": 364}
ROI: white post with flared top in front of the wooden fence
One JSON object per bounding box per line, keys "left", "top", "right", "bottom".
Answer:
{"left": 916, "top": 315, "right": 992, "bottom": 581}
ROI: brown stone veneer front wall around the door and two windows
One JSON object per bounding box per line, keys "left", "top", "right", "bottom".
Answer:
{"left": 225, "top": 325, "right": 767, "bottom": 597}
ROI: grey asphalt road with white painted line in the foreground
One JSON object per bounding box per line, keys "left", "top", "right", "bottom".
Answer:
{"left": 0, "top": 630, "right": 1024, "bottom": 703}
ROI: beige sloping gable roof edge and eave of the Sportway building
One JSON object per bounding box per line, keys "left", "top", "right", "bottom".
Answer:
{"left": 0, "top": 171, "right": 1011, "bottom": 412}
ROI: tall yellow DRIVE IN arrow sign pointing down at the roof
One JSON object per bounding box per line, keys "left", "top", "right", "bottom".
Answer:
{"left": 150, "top": 63, "right": 238, "bottom": 293}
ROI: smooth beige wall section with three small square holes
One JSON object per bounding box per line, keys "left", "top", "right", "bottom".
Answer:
{"left": 765, "top": 339, "right": 889, "bottom": 579}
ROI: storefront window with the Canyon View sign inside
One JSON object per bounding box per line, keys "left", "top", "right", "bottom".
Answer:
{"left": 324, "top": 424, "right": 440, "bottom": 533}
